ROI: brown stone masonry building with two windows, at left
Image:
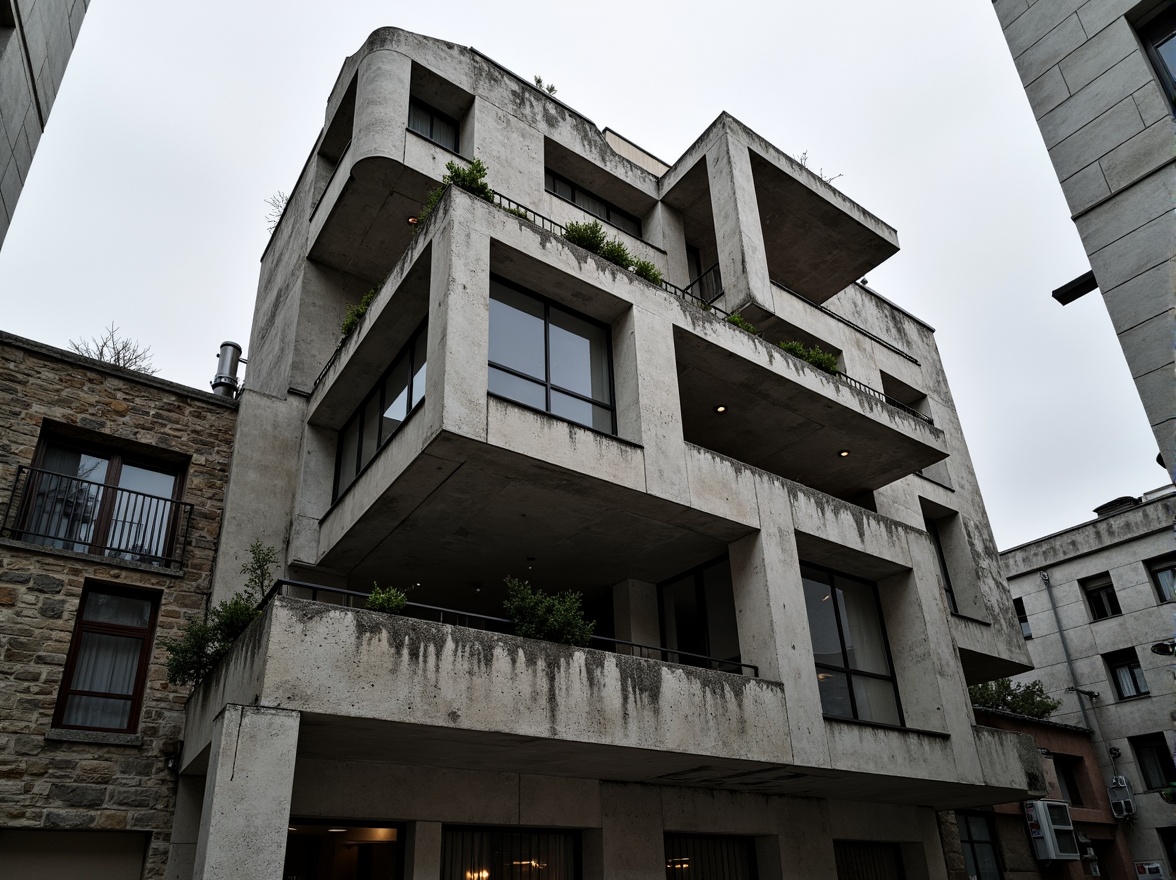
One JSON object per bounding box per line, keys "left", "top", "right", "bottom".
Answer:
{"left": 0, "top": 333, "right": 236, "bottom": 880}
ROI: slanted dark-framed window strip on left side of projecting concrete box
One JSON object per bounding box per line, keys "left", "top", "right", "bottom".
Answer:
{"left": 335, "top": 324, "right": 428, "bottom": 498}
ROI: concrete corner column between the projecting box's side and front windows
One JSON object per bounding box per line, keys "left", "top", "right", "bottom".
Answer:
{"left": 425, "top": 203, "right": 490, "bottom": 441}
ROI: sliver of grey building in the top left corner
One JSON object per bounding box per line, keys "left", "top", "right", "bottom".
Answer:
{"left": 0, "top": 0, "right": 89, "bottom": 245}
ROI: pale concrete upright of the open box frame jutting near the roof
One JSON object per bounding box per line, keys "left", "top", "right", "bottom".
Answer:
{"left": 707, "top": 133, "right": 773, "bottom": 312}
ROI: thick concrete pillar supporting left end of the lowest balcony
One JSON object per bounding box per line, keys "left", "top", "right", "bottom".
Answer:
{"left": 193, "top": 705, "right": 299, "bottom": 880}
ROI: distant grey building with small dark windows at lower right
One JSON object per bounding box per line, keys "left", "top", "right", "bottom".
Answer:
{"left": 1001, "top": 486, "right": 1176, "bottom": 876}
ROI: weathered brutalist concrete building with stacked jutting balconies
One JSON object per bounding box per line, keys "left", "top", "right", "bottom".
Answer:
{"left": 168, "top": 28, "right": 1042, "bottom": 880}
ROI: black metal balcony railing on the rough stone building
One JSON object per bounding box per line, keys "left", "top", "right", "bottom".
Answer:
{"left": 0, "top": 465, "right": 192, "bottom": 568}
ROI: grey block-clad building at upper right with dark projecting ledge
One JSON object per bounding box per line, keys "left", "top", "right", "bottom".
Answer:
{"left": 993, "top": 0, "right": 1176, "bottom": 474}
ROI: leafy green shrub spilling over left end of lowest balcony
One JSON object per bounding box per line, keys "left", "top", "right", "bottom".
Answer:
{"left": 160, "top": 540, "right": 278, "bottom": 685}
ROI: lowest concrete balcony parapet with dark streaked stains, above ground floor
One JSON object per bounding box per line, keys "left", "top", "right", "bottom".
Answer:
{"left": 181, "top": 596, "right": 1036, "bottom": 808}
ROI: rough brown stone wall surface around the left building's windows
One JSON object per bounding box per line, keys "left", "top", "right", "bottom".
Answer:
{"left": 0, "top": 334, "right": 236, "bottom": 878}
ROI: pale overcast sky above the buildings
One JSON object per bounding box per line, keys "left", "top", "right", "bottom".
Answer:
{"left": 0, "top": 0, "right": 1165, "bottom": 548}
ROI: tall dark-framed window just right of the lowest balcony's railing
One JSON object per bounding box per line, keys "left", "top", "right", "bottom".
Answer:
{"left": 801, "top": 564, "right": 903, "bottom": 725}
